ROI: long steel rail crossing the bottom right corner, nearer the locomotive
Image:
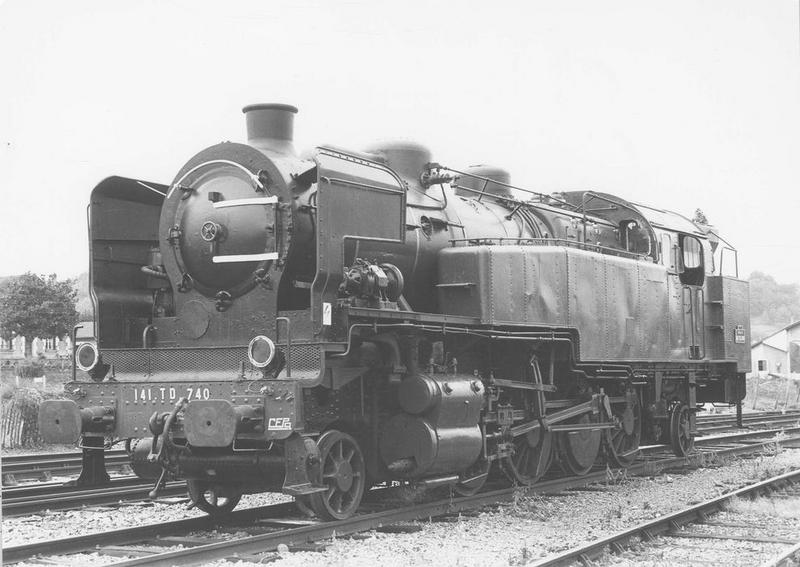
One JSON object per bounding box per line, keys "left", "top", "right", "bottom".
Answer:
{"left": 531, "top": 470, "right": 800, "bottom": 567}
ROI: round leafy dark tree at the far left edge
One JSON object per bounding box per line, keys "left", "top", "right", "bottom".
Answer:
{"left": 0, "top": 272, "right": 78, "bottom": 356}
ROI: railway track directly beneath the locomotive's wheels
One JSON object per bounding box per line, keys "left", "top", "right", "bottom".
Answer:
{"left": 3, "top": 432, "right": 800, "bottom": 566}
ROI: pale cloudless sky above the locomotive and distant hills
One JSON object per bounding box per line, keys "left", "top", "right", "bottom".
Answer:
{"left": 0, "top": 0, "right": 800, "bottom": 283}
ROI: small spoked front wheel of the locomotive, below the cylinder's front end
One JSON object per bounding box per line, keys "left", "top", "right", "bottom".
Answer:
{"left": 309, "top": 429, "right": 366, "bottom": 520}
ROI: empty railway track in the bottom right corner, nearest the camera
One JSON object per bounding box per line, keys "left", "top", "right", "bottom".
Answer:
{"left": 533, "top": 471, "right": 800, "bottom": 567}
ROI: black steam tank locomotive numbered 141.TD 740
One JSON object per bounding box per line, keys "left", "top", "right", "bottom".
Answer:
{"left": 39, "top": 104, "right": 750, "bottom": 519}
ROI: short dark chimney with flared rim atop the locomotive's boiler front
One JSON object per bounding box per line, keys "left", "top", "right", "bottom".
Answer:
{"left": 242, "top": 103, "right": 297, "bottom": 155}
